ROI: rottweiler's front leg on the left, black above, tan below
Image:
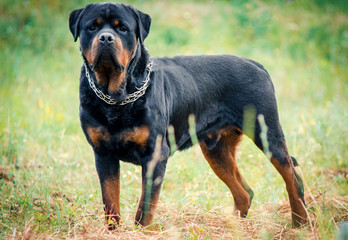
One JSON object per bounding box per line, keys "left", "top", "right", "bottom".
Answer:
{"left": 94, "top": 152, "right": 121, "bottom": 230}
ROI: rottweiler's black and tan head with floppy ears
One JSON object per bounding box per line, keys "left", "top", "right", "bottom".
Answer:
{"left": 69, "top": 3, "right": 151, "bottom": 93}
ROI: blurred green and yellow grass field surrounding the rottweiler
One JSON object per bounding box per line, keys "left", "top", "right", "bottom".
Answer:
{"left": 0, "top": 0, "right": 348, "bottom": 239}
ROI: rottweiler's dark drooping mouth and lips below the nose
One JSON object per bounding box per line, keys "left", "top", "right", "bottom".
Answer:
{"left": 92, "top": 46, "right": 125, "bottom": 73}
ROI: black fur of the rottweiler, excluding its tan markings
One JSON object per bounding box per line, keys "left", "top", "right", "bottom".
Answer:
{"left": 70, "top": 3, "right": 304, "bottom": 229}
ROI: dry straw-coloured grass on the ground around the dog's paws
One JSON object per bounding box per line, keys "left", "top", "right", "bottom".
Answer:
{"left": 8, "top": 189, "right": 348, "bottom": 240}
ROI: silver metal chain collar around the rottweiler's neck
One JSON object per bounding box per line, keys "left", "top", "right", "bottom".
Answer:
{"left": 83, "top": 59, "right": 153, "bottom": 105}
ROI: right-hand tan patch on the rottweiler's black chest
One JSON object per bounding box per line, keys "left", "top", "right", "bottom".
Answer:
{"left": 121, "top": 126, "right": 150, "bottom": 148}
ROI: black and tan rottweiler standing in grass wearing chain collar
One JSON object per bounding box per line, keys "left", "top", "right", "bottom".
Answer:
{"left": 69, "top": 3, "right": 307, "bottom": 229}
